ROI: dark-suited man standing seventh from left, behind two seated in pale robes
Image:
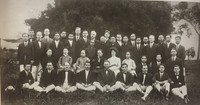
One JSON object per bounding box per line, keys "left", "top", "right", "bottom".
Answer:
{"left": 66, "top": 34, "right": 77, "bottom": 63}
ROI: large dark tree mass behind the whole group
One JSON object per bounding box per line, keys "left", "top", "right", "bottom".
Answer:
{"left": 25, "top": 0, "right": 173, "bottom": 37}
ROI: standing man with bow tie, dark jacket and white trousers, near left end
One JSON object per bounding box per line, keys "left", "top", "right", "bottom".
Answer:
{"left": 31, "top": 31, "right": 46, "bottom": 81}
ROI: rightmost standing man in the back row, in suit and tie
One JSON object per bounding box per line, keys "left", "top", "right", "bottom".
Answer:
{"left": 175, "top": 36, "right": 185, "bottom": 62}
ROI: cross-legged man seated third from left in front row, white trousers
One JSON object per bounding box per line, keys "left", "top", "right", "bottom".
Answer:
{"left": 55, "top": 62, "right": 77, "bottom": 93}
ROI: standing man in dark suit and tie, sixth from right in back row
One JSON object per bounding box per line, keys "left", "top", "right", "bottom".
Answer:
{"left": 132, "top": 37, "right": 144, "bottom": 65}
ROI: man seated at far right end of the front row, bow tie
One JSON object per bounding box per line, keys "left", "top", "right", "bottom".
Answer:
{"left": 171, "top": 65, "right": 190, "bottom": 103}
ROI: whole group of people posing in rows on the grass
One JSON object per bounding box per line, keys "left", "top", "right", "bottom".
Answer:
{"left": 6, "top": 27, "right": 189, "bottom": 103}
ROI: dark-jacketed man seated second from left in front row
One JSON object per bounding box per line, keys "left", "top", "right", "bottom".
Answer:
{"left": 34, "top": 62, "right": 57, "bottom": 96}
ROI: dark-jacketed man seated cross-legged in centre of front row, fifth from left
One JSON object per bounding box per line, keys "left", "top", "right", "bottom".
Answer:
{"left": 94, "top": 60, "right": 115, "bottom": 92}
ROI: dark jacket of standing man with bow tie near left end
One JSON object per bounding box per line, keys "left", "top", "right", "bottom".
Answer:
{"left": 33, "top": 40, "right": 46, "bottom": 65}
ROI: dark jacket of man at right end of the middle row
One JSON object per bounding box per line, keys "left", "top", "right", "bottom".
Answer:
{"left": 165, "top": 57, "right": 183, "bottom": 76}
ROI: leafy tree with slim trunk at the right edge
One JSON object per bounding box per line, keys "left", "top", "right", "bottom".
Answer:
{"left": 172, "top": 2, "right": 200, "bottom": 60}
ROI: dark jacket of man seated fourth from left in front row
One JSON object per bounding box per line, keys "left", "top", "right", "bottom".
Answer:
{"left": 77, "top": 70, "right": 94, "bottom": 84}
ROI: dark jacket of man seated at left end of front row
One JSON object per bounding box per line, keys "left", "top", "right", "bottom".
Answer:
{"left": 18, "top": 70, "right": 34, "bottom": 87}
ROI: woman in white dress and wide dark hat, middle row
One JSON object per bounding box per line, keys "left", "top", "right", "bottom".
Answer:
{"left": 108, "top": 48, "right": 121, "bottom": 76}
